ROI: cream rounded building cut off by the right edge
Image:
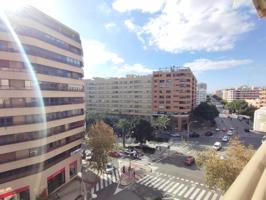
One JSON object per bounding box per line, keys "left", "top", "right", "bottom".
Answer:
{"left": 253, "top": 107, "right": 266, "bottom": 133}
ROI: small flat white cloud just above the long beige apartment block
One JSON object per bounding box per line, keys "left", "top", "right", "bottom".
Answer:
{"left": 112, "top": 64, "right": 153, "bottom": 76}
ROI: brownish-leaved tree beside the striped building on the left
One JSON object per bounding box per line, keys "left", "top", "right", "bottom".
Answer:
{"left": 86, "top": 121, "right": 115, "bottom": 173}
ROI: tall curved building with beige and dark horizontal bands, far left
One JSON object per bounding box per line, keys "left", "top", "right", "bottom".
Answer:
{"left": 0, "top": 7, "right": 84, "bottom": 200}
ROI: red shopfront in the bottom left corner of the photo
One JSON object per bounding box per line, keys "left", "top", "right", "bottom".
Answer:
{"left": 0, "top": 186, "right": 30, "bottom": 200}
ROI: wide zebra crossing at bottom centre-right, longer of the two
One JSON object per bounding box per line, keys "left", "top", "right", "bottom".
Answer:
{"left": 136, "top": 172, "right": 221, "bottom": 200}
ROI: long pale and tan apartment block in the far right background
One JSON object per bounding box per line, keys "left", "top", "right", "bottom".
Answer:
{"left": 223, "top": 86, "right": 260, "bottom": 102}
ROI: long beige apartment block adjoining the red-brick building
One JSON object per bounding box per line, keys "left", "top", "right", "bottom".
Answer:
{"left": 85, "top": 75, "right": 152, "bottom": 116}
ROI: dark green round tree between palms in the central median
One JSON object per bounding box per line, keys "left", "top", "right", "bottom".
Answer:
{"left": 133, "top": 119, "right": 153, "bottom": 144}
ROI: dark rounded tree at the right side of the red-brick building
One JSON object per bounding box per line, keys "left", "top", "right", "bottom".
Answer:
{"left": 192, "top": 102, "right": 219, "bottom": 121}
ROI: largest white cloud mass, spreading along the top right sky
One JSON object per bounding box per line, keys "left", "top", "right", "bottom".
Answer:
{"left": 120, "top": 0, "right": 254, "bottom": 53}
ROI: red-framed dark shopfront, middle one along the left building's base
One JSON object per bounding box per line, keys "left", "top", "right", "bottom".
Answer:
{"left": 47, "top": 168, "right": 65, "bottom": 194}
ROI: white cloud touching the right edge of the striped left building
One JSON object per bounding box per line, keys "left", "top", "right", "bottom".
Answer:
{"left": 82, "top": 39, "right": 124, "bottom": 78}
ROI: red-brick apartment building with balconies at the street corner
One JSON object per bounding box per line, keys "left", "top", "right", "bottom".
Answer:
{"left": 152, "top": 67, "right": 197, "bottom": 130}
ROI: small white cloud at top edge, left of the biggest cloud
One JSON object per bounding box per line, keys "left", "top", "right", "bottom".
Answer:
{"left": 112, "top": 0, "right": 165, "bottom": 13}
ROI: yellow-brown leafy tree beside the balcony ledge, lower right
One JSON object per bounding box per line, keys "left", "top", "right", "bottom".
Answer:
{"left": 196, "top": 138, "right": 255, "bottom": 191}
